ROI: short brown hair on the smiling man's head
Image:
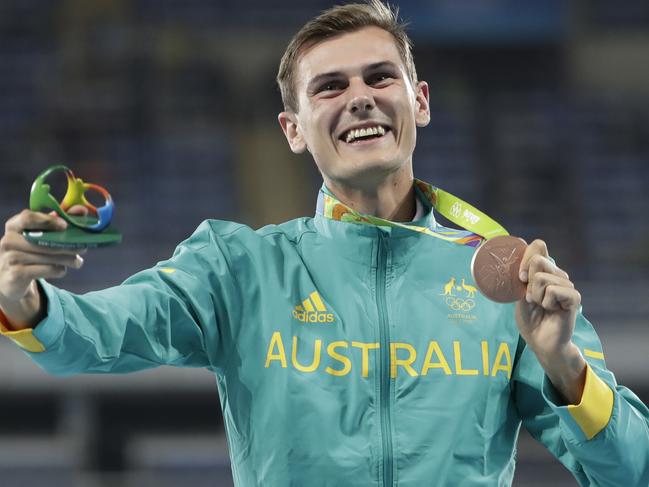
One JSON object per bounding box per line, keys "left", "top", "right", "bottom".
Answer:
{"left": 277, "top": 0, "right": 417, "bottom": 113}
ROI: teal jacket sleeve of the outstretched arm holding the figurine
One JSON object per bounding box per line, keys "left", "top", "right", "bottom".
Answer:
{"left": 0, "top": 222, "right": 238, "bottom": 375}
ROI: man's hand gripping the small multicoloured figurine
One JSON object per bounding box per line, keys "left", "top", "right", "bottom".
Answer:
{"left": 0, "top": 206, "right": 87, "bottom": 329}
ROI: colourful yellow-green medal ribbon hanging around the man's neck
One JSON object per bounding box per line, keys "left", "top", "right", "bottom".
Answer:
{"left": 317, "top": 179, "right": 509, "bottom": 247}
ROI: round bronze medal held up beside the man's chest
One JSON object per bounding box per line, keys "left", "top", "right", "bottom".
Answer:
{"left": 471, "top": 235, "right": 527, "bottom": 303}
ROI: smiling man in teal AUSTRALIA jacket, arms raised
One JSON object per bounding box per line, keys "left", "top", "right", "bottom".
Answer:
{"left": 0, "top": 1, "right": 649, "bottom": 487}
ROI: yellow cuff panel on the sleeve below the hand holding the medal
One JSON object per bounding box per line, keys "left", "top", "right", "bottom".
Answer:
{"left": 568, "top": 365, "right": 613, "bottom": 440}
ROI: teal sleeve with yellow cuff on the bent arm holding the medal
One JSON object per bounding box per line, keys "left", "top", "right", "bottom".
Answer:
{"left": 512, "top": 312, "right": 649, "bottom": 487}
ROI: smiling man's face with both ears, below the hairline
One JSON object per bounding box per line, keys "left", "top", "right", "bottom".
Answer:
{"left": 279, "top": 27, "right": 430, "bottom": 186}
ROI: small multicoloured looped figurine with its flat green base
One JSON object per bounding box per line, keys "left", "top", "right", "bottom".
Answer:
{"left": 23, "top": 165, "right": 122, "bottom": 248}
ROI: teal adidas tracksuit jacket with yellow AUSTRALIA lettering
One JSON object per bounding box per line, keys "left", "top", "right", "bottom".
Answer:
{"left": 2, "top": 181, "right": 649, "bottom": 487}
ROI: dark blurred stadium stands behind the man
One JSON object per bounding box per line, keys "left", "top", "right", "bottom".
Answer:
{"left": 0, "top": 0, "right": 649, "bottom": 487}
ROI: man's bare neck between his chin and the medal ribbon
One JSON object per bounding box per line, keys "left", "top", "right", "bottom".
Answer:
{"left": 325, "top": 168, "right": 417, "bottom": 222}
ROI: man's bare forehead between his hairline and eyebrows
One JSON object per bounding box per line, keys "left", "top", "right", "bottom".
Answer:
{"left": 296, "top": 27, "right": 404, "bottom": 86}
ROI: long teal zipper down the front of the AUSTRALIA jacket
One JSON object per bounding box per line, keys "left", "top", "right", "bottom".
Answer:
{"left": 376, "top": 229, "right": 393, "bottom": 487}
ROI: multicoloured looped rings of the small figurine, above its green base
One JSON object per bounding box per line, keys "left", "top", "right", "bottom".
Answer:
{"left": 29, "top": 165, "right": 115, "bottom": 232}
